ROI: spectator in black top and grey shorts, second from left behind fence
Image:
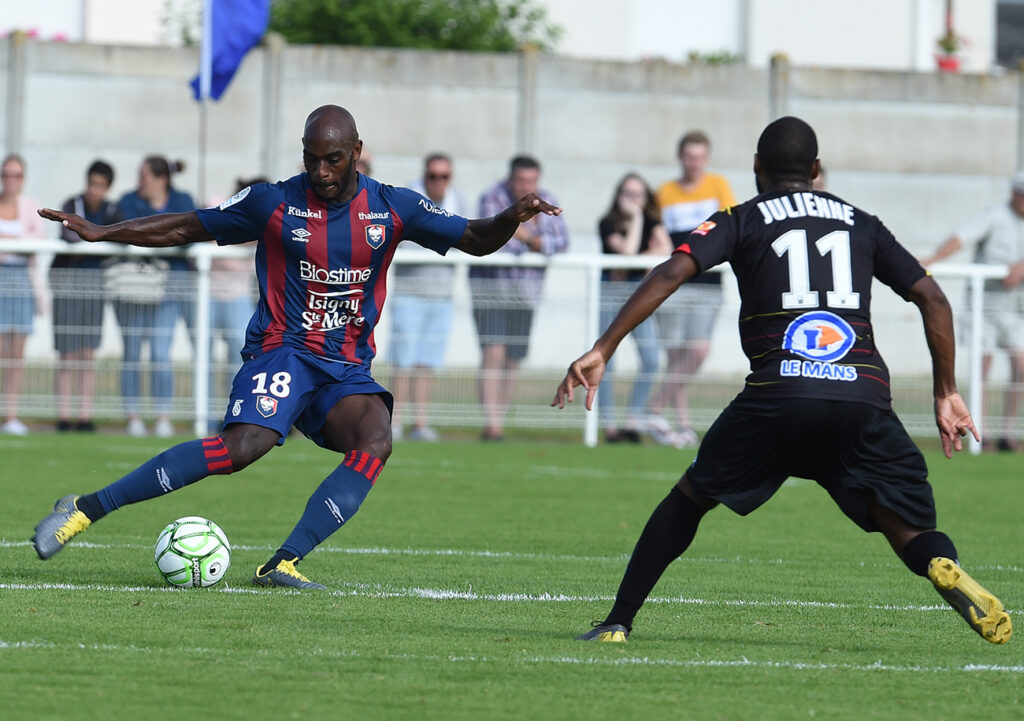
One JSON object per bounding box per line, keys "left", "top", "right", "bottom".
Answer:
{"left": 50, "top": 160, "right": 121, "bottom": 432}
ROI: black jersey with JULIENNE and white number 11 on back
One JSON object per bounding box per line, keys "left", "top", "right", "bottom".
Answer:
{"left": 676, "top": 190, "right": 926, "bottom": 408}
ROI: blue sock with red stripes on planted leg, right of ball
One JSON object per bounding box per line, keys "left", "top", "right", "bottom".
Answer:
{"left": 281, "top": 451, "right": 384, "bottom": 559}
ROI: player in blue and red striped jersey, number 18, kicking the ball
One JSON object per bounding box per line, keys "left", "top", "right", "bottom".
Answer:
{"left": 33, "top": 105, "right": 561, "bottom": 588}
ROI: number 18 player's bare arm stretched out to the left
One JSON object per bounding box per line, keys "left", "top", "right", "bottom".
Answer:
{"left": 37, "top": 208, "right": 213, "bottom": 248}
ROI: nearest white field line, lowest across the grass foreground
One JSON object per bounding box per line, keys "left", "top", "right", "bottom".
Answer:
{"left": 0, "top": 639, "right": 1024, "bottom": 674}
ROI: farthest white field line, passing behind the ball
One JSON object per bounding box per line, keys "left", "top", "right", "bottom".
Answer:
{"left": 0, "top": 539, "right": 1024, "bottom": 574}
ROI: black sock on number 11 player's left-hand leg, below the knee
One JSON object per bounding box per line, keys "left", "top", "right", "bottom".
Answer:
{"left": 604, "top": 487, "right": 705, "bottom": 630}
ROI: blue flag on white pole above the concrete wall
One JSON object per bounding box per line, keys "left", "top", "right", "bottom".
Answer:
{"left": 191, "top": 0, "right": 270, "bottom": 100}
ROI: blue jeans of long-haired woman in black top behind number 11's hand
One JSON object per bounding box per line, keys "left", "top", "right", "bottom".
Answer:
{"left": 597, "top": 281, "right": 662, "bottom": 428}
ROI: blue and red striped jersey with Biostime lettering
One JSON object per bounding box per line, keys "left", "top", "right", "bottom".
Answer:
{"left": 197, "top": 173, "right": 468, "bottom": 365}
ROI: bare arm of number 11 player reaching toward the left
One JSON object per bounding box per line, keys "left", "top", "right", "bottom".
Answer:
{"left": 551, "top": 253, "right": 699, "bottom": 411}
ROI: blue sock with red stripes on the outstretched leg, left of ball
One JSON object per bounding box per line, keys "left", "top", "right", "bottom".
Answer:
{"left": 95, "top": 435, "right": 232, "bottom": 514}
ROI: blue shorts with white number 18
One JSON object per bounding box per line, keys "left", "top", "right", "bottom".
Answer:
{"left": 223, "top": 346, "right": 394, "bottom": 448}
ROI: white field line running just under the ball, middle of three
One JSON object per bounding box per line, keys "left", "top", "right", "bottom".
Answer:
{"left": 0, "top": 583, "right": 1013, "bottom": 612}
